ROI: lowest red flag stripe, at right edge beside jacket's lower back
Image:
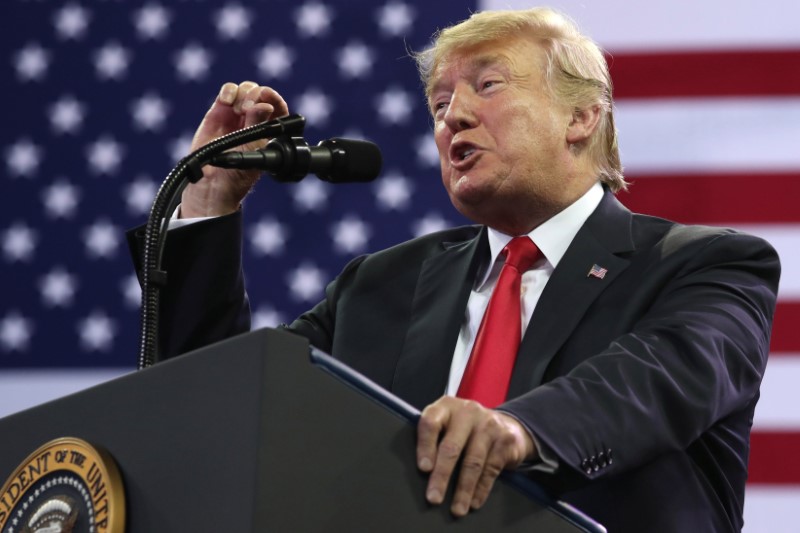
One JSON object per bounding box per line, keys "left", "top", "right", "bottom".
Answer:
{"left": 747, "top": 431, "right": 800, "bottom": 485}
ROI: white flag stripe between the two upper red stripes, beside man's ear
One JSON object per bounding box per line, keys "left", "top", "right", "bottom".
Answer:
{"left": 616, "top": 97, "right": 800, "bottom": 174}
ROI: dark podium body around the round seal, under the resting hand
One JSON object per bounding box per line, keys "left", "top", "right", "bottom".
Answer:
{"left": 0, "top": 330, "right": 605, "bottom": 533}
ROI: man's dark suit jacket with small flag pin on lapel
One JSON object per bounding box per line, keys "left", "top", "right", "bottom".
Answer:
{"left": 130, "top": 192, "right": 780, "bottom": 533}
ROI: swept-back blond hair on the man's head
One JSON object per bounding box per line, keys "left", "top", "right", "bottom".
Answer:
{"left": 414, "top": 7, "right": 627, "bottom": 192}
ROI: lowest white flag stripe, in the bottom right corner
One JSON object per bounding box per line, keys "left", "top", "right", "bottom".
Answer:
{"left": 742, "top": 486, "right": 800, "bottom": 533}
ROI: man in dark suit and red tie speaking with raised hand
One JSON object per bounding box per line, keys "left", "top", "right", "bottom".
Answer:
{"left": 133, "top": 9, "right": 779, "bottom": 532}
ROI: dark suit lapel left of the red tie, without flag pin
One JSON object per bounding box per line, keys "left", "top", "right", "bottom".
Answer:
{"left": 392, "top": 228, "right": 488, "bottom": 409}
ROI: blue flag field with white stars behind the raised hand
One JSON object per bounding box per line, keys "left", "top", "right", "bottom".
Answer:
{"left": 0, "top": 0, "right": 469, "bottom": 368}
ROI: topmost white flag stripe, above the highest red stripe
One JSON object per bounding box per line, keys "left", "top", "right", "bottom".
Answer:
{"left": 479, "top": 0, "right": 800, "bottom": 51}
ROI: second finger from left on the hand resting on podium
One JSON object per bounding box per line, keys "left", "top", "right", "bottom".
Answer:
{"left": 427, "top": 400, "right": 481, "bottom": 503}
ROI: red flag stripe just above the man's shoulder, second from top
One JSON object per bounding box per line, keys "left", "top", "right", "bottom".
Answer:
{"left": 618, "top": 172, "right": 800, "bottom": 224}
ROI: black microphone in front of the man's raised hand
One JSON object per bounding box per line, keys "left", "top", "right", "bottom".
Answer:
{"left": 208, "top": 136, "right": 383, "bottom": 183}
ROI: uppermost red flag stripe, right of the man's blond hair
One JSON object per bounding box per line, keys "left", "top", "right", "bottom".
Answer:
{"left": 608, "top": 50, "right": 800, "bottom": 98}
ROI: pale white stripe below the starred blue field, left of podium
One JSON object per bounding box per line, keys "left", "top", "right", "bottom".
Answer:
{"left": 0, "top": 368, "right": 132, "bottom": 418}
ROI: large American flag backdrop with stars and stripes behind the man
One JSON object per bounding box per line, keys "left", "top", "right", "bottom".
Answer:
{"left": 0, "top": 0, "right": 800, "bottom": 533}
